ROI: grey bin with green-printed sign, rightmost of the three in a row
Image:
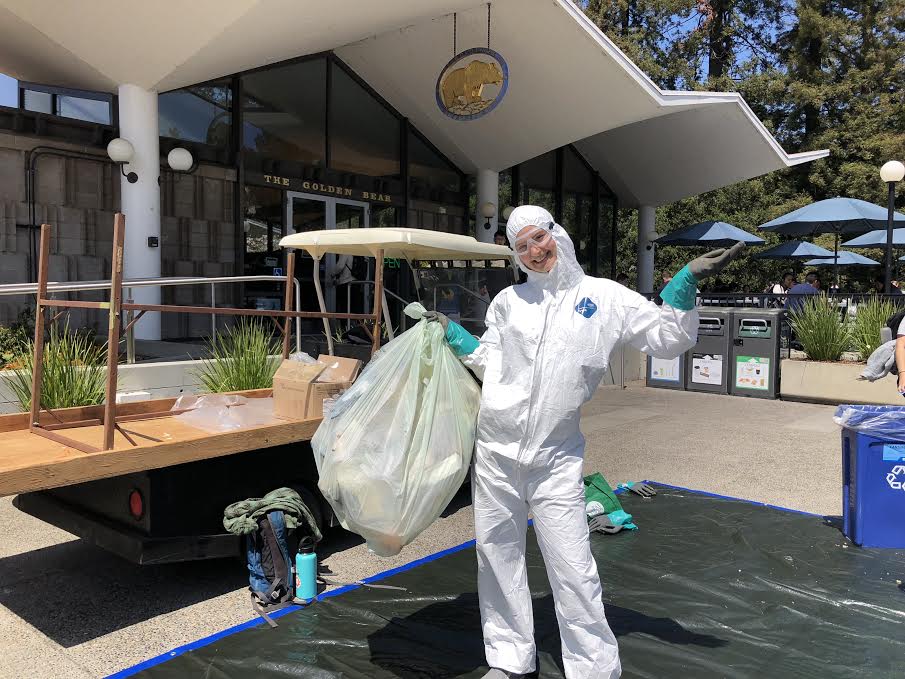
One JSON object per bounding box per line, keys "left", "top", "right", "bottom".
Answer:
{"left": 729, "top": 308, "right": 785, "bottom": 399}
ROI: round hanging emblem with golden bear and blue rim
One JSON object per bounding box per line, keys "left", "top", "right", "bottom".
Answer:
{"left": 437, "top": 47, "right": 509, "bottom": 120}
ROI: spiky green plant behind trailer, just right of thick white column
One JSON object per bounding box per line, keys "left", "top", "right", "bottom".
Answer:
{"left": 195, "top": 321, "right": 279, "bottom": 393}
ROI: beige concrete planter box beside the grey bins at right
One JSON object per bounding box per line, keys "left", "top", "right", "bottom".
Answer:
{"left": 780, "top": 359, "right": 905, "bottom": 405}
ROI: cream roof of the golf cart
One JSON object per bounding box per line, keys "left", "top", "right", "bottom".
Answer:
{"left": 280, "top": 227, "right": 514, "bottom": 261}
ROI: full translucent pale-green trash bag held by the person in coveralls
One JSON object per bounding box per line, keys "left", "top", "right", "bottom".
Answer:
{"left": 311, "top": 304, "right": 481, "bottom": 556}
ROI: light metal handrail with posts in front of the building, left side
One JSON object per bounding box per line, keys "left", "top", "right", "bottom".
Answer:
{"left": 0, "top": 276, "right": 302, "bottom": 363}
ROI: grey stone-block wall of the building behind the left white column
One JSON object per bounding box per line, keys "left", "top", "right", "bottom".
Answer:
{"left": 0, "top": 132, "right": 238, "bottom": 339}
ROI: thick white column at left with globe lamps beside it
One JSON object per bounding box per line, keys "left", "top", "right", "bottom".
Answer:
{"left": 119, "top": 85, "right": 161, "bottom": 340}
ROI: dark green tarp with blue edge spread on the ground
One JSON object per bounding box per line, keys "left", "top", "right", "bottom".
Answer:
{"left": 129, "top": 486, "right": 905, "bottom": 679}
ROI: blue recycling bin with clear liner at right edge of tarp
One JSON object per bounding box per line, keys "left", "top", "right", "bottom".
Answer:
{"left": 836, "top": 406, "right": 905, "bottom": 549}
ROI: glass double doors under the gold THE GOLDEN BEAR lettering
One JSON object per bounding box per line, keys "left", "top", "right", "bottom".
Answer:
{"left": 286, "top": 191, "right": 371, "bottom": 322}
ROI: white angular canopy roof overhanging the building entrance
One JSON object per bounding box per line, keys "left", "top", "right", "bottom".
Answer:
{"left": 0, "top": 0, "right": 827, "bottom": 206}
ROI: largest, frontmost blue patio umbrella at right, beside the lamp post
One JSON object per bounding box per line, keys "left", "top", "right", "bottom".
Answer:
{"left": 759, "top": 198, "right": 905, "bottom": 285}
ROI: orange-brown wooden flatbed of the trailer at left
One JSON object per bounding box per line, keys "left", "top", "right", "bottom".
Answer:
{"left": 0, "top": 389, "right": 320, "bottom": 497}
